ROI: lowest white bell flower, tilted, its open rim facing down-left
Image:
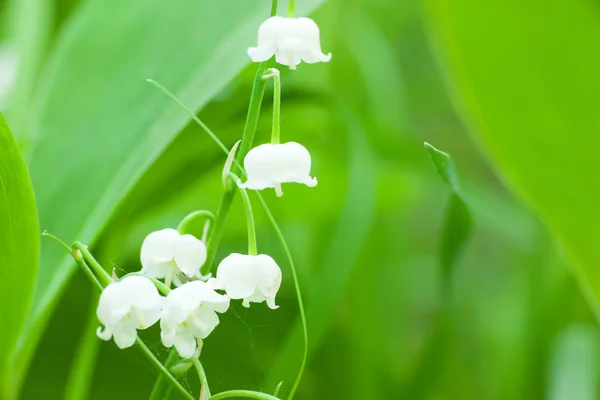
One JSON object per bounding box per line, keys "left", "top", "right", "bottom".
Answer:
{"left": 160, "top": 281, "right": 229, "bottom": 358}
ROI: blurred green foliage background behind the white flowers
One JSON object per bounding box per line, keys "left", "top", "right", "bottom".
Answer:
{"left": 0, "top": 0, "right": 600, "bottom": 400}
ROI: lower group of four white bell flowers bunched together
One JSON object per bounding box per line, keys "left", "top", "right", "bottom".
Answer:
{"left": 97, "top": 229, "right": 281, "bottom": 358}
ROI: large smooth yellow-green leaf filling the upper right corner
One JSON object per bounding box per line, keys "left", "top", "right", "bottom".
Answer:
{"left": 423, "top": 0, "right": 600, "bottom": 315}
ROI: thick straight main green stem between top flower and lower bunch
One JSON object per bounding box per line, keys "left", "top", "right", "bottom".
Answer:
{"left": 200, "top": 62, "right": 266, "bottom": 275}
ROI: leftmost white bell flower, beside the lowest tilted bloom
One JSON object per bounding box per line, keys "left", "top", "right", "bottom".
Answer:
{"left": 96, "top": 276, "right": 164, "bottom": 349}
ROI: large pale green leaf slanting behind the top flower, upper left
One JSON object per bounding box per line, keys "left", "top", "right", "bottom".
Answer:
{"left": 12, "top": 0, "right": 320, "bottom": 390}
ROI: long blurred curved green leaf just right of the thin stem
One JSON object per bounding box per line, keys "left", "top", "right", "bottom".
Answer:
{"left": 267, "top": 105, "right": 378, "bottom": 388}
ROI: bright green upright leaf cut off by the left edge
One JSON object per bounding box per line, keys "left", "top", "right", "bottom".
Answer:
{"left": 0, "top": 114, "right": 40, "bottom": 399}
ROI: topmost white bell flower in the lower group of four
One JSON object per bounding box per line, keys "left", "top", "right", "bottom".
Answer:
{"left": 141, "top": 229, "right": 206, "bottom": 284}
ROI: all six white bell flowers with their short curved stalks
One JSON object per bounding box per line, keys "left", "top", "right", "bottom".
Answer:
{"left": 97, "top": 10, "right": 331, "bottom": 366}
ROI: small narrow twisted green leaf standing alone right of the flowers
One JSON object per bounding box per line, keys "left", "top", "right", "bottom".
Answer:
{"left": 425, "top": 143, "right": 473, "bottom": 284}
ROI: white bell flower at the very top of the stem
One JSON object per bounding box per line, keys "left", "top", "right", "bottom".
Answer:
{"left": 248, "top": 17, "right": 331, "bottom": 69}
